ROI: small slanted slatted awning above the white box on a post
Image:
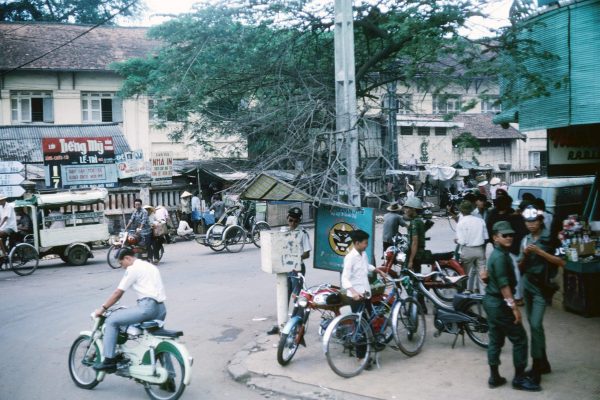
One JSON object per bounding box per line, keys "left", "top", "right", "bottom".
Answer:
{"left": 240, "top": 173, "right": 314, "bottom": 202}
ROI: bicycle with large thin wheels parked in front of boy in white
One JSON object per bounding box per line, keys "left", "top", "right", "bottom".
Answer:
{"left": 323, "top": 277, "right": 426, "bottom": 378}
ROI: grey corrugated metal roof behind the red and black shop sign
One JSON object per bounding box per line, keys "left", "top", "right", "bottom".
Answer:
{"left": 0, "top": 124, "right": 131, "bottom": 163}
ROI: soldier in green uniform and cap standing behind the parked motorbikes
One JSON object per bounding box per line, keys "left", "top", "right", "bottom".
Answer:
{"left": 403, "top": 197, "right": 427, "bottom": 314}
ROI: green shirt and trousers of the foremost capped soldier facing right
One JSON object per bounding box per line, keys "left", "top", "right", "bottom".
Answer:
{"left": 483, "top": 246, "right": 528, "bottom": 368}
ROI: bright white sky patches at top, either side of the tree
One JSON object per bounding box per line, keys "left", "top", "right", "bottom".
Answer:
{"left": 125, "top": 0, "right": 512, "bottom": 38}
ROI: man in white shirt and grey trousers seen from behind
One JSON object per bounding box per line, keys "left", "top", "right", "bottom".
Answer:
{"left": 456, "top": 201, "right": 488, "bottom": 293}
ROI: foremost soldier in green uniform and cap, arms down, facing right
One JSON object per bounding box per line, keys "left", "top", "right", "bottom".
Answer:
{"left": 483, "top": 221, "right": 541, "bottom": 392}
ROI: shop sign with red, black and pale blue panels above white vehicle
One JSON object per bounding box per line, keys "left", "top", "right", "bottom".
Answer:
{"left": 42, "top": 137, "right": 118, "bottom": 189}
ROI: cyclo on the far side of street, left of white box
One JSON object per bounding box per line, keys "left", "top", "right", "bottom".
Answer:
{"left": 196, "top": 203, "right": 271, "bottom": 253}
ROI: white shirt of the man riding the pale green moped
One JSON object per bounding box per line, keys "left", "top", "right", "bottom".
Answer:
{"left": 118, "top": 260, "right": 167, "bottom": 303}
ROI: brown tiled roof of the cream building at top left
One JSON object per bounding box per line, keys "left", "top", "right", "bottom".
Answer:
{"left": 0, "top": 22, "right": 160, "bottom": 71}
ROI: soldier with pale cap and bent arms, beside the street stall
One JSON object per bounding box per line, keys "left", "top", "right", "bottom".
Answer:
{"left": 519, "top": 206, "right": 565, "bottom": 384}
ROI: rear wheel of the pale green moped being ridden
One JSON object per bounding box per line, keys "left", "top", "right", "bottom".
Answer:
{"left": 144, "top": 349, "right": 185, "bottom": 400}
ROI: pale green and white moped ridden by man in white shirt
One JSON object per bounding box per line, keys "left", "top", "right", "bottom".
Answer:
{"left": 69, "top": 307, "right": 193, "bottom": 400}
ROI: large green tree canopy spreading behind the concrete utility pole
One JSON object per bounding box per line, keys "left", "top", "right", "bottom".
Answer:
{"left": 115, "top": 0, "right": 560, "bottom": 200}
